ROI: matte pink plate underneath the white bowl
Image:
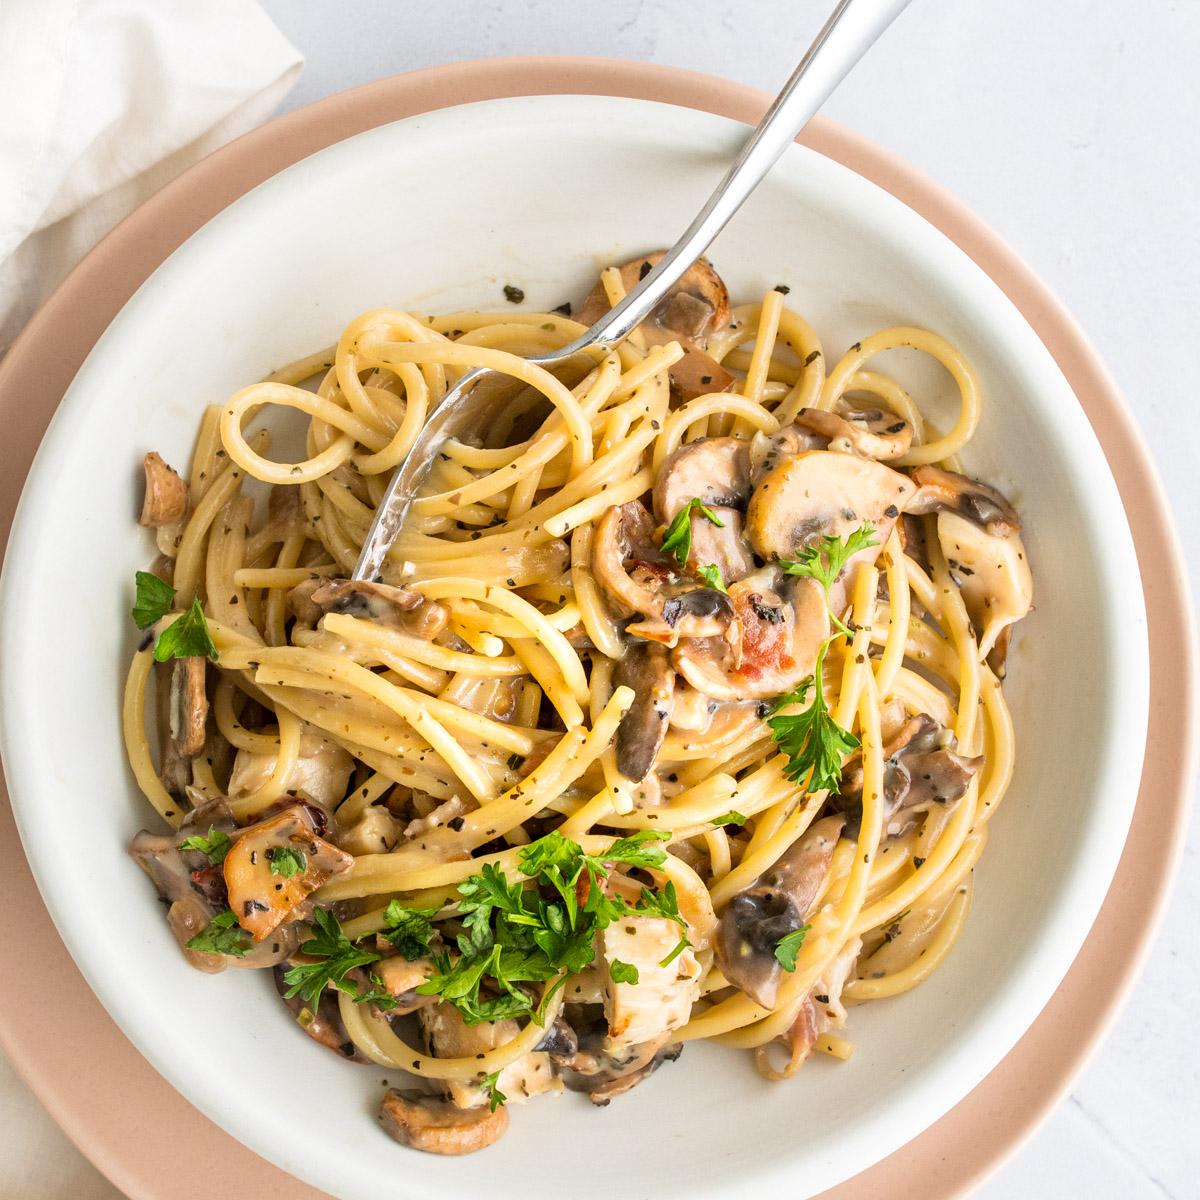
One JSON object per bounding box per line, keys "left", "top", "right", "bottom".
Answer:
{"left": 0, "top": 60, "right": 1193, "bottom": 1198}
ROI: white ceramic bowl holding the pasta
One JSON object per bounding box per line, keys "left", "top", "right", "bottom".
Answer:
{"left": 0, "top": 97, "right": 1147, "bottom": 1200}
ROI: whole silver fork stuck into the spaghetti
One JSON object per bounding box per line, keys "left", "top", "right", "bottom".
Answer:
{"left": 353, "top": 0, "right": 908, "bottom": 582}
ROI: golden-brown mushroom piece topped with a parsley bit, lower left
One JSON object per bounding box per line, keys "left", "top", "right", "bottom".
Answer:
{"left": 224, "top": 804, "right": 354, "bottom": 942}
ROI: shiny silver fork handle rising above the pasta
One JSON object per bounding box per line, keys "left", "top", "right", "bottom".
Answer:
{"left": 554, "top": 0, "right": 908, "bottom": 360}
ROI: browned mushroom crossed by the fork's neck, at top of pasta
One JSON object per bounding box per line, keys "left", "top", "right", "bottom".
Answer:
{"left": 575, "top": 250, "right": 733, "bottom": 400}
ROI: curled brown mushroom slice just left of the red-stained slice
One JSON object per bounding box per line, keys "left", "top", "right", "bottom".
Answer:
{"left": 592, "top": 500, "right": 737, "bottom": 646}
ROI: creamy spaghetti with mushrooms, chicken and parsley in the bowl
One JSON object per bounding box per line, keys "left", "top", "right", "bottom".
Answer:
{"left": 122, "top": 256, "right": 1032, "bottom": 1153}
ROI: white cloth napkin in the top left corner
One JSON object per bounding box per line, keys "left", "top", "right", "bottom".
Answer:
{"left": 0, "top": 0, "right": 302, "bottom": 354}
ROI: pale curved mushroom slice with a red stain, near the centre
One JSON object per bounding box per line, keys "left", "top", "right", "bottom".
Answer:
{"left": 671, "top": 568, "right": 829, "bottom": 701}
